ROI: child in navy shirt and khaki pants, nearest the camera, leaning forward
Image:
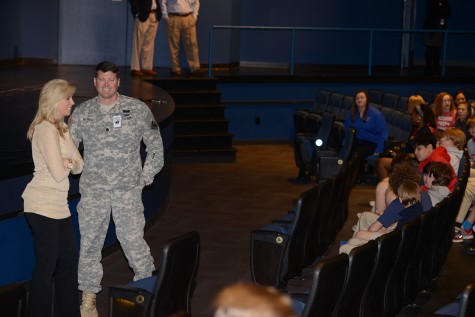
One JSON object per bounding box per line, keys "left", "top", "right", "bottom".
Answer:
{"left": 340, "top": 180, "right": 423, "bottom": 254}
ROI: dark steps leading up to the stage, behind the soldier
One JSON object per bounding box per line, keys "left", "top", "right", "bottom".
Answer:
{"left": 149, "top": 78, "right": 236, "bottom": 162}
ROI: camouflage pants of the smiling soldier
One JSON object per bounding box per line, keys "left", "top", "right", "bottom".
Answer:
{"left": 77, "top": 187, "right": 155, "bottom": 293}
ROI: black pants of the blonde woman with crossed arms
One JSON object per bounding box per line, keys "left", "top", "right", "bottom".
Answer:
{"left": 25, "top": 213, "right": 80, "bottom": 317}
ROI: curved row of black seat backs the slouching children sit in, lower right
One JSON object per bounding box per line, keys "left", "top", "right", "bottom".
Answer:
{"left": 292, "top": 154, "right": 473, "bottom": 317}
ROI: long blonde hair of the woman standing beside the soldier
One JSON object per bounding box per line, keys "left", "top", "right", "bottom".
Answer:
{"left": 26, "top": 79, "right": 76, "bottom": 140}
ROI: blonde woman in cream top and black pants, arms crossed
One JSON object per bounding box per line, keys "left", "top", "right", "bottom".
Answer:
{"left": 22, "top": 79, "right": 83, "bottom": 317}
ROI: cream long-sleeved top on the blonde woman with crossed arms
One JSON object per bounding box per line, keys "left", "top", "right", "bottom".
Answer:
{"left": 22, "top": 121, "right": 84, "bottom": 219}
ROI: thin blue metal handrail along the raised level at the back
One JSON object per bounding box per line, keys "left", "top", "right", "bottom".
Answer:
{"left": 208, "top": 25, "right": 475, "bottom": 77}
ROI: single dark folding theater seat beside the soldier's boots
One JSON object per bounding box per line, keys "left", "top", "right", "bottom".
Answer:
{"left": 109, "top": 231, "right": 200, "bottom": 317}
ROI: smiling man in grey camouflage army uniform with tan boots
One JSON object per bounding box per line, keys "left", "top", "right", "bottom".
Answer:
{"left": 70, "top": 62, "right": 163, "bottom": 317}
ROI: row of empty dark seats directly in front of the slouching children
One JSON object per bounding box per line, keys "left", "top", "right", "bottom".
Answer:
{"left": 251, "top": 156, "right": 360, "bottom": 289}
